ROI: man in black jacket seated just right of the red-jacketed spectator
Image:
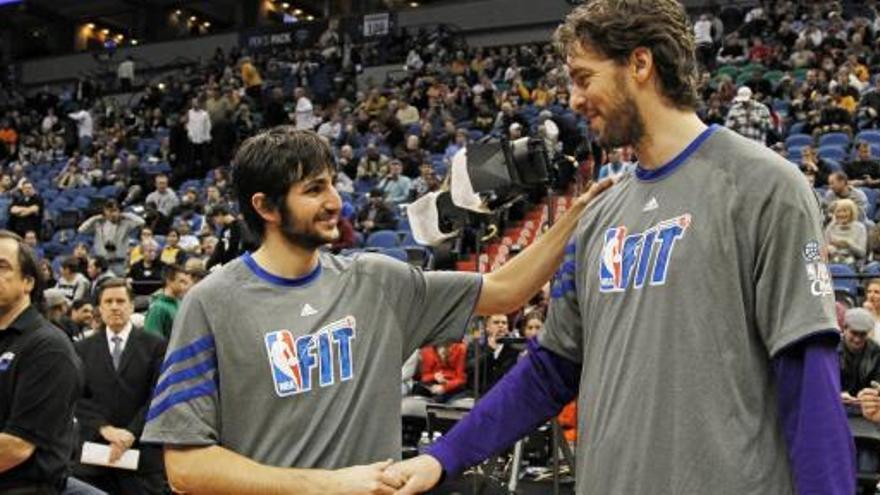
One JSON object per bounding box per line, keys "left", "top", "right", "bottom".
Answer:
{"left": 468, "top": 314, "right": 522, "bottom": 394}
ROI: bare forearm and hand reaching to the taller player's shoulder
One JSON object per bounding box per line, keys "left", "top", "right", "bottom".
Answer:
{"left": 476, "top": 179, "right": 611, "bottom": 315}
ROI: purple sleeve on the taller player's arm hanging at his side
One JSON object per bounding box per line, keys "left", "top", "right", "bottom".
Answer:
{"left": 773, "top": 331, "right": 856, "bottom": 495}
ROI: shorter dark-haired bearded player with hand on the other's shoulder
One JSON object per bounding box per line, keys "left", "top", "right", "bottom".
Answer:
{"left": 144, "top": 127, "right": 608, "bottom": 494}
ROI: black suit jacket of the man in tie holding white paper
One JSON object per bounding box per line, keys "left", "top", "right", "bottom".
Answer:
{"left": 74, "top": 328, "right": 167, "bottom": 476}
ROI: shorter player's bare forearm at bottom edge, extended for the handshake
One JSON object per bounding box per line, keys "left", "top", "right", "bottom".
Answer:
{"left": 165, "top": 445, "right": 330, "bottom": 495}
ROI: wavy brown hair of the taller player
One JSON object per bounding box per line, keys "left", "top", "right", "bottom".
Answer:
{"left": 555, "top": 0, "right": 697, "bottom": 109}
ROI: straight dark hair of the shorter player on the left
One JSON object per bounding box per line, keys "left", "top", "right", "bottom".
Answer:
{"left": 232, "top": 126, "right": 336, "bottom": 238}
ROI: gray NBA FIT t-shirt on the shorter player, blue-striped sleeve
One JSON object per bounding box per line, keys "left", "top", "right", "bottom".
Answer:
{"left": 143, "top": 254, "right": 482, "bottom": 468}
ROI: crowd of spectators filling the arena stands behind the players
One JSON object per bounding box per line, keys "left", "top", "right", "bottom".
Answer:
{"left": 6, "top": 0, "right": 880, "bottom": 488}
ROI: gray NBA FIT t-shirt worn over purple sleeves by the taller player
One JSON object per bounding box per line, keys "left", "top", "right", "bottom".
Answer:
{"left": 540, "top": 128, "right": 836, "bottom": 495}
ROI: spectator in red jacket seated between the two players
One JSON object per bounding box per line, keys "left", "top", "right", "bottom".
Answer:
{"left": 413, "top": 342, "right": 467, "bottom": 403}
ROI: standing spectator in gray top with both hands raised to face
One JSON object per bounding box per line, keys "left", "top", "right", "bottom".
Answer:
{"left": 78, "top": 199, "right": 145, "bottom": 274}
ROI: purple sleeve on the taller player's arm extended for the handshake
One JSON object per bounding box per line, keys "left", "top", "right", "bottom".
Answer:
{"left": 428, "top": 340, "right": 581, "bottom": 476}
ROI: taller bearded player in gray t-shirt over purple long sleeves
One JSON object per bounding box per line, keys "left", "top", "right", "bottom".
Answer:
{"left": 388, "top": 0, "right": 855, "bottom": 495}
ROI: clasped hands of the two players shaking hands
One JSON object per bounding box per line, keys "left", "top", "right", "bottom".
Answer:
{"left": 330, "top": 455, "right": 443, "bottom": 495}
